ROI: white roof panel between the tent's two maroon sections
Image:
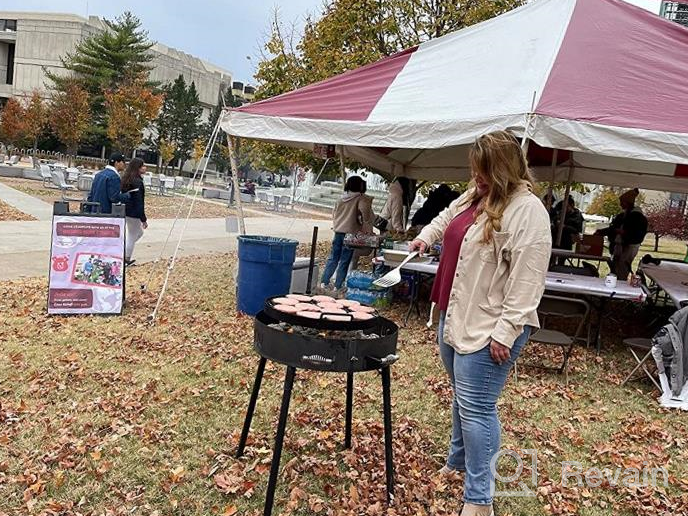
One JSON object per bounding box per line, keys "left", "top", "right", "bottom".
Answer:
{"left": 368, "top": 0, "right": 576, "bottom": 124}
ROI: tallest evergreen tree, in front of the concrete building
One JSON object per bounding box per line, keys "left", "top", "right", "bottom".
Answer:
{"left": 47, "top": 12, "right": 155, "bottom": 145}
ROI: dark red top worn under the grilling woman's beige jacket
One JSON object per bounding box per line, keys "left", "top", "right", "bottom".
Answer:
{"left": 430, "top": 203, "right": 478, "bottom": 311}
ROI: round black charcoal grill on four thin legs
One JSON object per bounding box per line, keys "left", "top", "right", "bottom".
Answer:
{"left": 236, "top": 303, "right": 399, "bottom": 516}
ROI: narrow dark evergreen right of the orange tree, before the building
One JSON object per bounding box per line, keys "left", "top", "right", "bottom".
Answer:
{"left": 154, "top": 75, "right": 203, "bottom": 170}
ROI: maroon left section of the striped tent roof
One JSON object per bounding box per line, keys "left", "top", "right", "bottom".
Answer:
{"left": 237, "top": 47, "right": 418, "bottom": 121}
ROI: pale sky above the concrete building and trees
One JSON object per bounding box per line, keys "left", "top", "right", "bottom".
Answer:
{"left": 0, "top": 0, "right": 661, "bottom": 83}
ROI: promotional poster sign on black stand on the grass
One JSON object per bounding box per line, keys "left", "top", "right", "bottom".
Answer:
{"left": 48, "top": 202, "right": 125, "bottom": 315}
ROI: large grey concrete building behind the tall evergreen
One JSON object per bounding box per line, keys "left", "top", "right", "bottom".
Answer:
{"left": 0, "top": 11, "right": 253, "bottom": 118}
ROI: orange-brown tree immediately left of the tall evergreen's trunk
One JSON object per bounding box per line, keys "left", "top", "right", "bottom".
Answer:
{"left": 50, "top": 81, "right": 91, "bottom": 160}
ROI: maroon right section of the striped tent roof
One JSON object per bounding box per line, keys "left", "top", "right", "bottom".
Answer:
{"left": 535, "top": 0, "right": 688, "bottom": 133}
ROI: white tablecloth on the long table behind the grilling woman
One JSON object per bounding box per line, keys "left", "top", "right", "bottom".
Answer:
{"left": 390, "top": 262, "right": 646, "bottom": 303}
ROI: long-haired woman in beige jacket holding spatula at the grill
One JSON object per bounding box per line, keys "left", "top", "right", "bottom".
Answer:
{"left": 410, "top": 131, "right": 552, "bottom": 516}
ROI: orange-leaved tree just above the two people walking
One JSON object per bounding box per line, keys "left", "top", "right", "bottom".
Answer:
{"left": 105, "top": 76, "right": 163, "bottom": 154}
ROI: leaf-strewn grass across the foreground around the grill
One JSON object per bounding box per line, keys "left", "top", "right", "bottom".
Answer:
{"left": 0, "top": 251, "right": 688, "bottom": 516}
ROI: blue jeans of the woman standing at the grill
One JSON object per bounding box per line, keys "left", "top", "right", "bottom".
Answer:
{"left": 437, "top": 312, "right": 532, "bottom": 505}
